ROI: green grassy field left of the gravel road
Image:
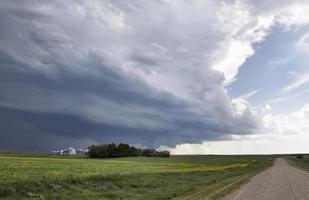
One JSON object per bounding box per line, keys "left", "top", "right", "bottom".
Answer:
{"left": 0, "top": 154, "right": 272, "bottom": 200}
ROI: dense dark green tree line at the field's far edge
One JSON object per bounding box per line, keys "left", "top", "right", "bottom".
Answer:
{"left": 88, "top": 143, "right": 170, "bottom": 158}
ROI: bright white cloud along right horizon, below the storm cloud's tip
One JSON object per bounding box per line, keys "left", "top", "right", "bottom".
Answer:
{"left": 165, "top": 104, "right": 309, "bottom": 154}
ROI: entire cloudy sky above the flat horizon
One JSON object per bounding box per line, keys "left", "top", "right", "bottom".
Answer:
{"left": 0, "top": 0, "right": 309, "bottom": 154}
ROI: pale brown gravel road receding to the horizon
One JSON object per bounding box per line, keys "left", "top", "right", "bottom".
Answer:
{"left": 225, "top": 158, "right": 309, "bottom": 200}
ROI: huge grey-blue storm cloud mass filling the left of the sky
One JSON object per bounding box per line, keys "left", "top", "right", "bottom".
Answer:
{"left": 0, "top": 1, "right": 257, "bottom": 150}
